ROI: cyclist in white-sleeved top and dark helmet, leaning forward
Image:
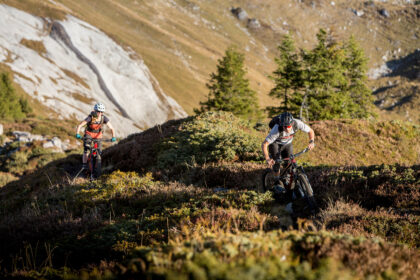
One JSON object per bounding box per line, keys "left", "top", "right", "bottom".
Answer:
{"left": 261, "top": 112, "right": 315, "bottom": 189}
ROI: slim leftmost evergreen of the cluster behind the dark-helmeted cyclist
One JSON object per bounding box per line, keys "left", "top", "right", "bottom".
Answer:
{"left": 266, "top": 35, "right": 302, "bottom": 117}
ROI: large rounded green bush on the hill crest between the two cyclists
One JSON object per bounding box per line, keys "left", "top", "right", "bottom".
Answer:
{"left": 158, "top": 112, "right": 262, "bottom": 168}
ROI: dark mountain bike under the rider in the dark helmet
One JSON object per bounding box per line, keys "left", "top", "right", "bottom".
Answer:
{"left": 262, "top": 148, "right": 318, "bottom": 213}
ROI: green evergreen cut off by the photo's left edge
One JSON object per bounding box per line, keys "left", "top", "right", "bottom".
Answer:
{"left": 0, "top": 73, "right": 32, "bottom": 119}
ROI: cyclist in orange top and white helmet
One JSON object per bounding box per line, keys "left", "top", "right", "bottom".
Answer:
{"left": 76, "top": 103, "right": 117, "bottom": 169}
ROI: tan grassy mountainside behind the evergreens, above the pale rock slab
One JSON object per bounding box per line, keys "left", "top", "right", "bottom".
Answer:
{"left": 0, "top": 0, "right": 420, "bottom": 117}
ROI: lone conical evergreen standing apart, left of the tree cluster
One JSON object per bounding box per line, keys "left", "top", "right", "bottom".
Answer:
{"left": 194, "top": 47, "right": 261, "bottom": 118}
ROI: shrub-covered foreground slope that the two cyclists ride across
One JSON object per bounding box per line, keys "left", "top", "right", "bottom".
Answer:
{"left": 0, "top": 112, "right": 420, "bottom": 279}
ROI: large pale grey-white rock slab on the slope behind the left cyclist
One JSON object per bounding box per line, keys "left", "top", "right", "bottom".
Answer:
{"left": 0, "top": 5, "right": 187, "bottom": 136}
